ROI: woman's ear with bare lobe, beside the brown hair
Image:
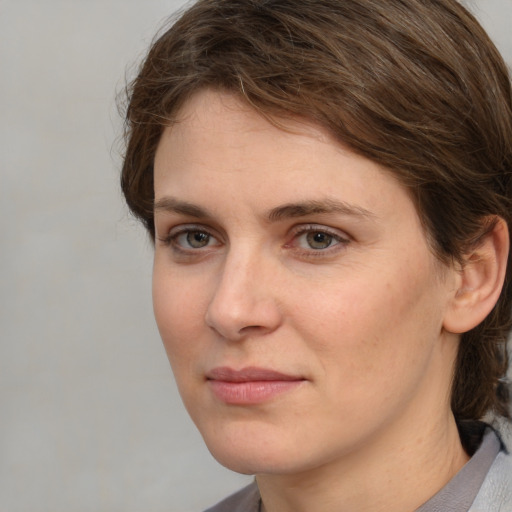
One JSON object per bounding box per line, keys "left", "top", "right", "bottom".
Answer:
{"left": 443, "top": 217, "right": 510, "bottom": 334}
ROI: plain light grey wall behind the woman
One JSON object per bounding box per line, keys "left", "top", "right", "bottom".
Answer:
{"left": 0, "top": 0, "right": 512, "bottom": 512}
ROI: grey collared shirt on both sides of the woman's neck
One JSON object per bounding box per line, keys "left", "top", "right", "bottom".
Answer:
{"left": 205, "top": 427, "right": 512, "bottom": 512}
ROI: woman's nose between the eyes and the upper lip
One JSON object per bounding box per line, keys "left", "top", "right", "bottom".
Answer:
{"left": 205, "top": 248, "right": 282, "bottom": 341}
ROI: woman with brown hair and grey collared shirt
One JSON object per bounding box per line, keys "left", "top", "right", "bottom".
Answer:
{"left": 122, "top": 0, "right": 512, "bottom": 512}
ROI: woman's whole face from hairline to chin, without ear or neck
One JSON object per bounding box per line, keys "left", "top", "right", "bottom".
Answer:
{"left": 153, "top": 91, "right": 458, "bottom": 473}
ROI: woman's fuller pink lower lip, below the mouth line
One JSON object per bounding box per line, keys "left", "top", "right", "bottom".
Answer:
{"left": 208, "top": 380, "right": 304, "bottom": 405}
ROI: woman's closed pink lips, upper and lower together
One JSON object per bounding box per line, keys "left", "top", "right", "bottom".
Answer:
{"left": 206, "top": 366, "right": 305, "bottom": 405}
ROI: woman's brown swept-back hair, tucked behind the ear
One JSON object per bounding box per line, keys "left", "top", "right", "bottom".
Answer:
{"left": 121, "top": 0, "right": 512, "bottom": 419}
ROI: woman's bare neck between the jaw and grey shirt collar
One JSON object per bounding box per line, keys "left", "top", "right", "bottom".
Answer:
{"left": 257, "top": 407, "right": 468, "bottom": 512}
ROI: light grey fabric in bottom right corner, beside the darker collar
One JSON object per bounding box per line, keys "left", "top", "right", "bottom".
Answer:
{"left": 470, "top": 418, "right": 512, "bottom": 512}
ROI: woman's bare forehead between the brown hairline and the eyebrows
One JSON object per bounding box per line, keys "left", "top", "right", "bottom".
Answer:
{"left": 155, "top": 90, "right": 414, "bottom": 220}
